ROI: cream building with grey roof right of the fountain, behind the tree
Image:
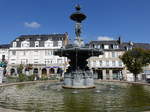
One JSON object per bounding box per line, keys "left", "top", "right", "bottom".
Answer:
{"left": 88, "top": 38, "right": 150, "bottom": 81}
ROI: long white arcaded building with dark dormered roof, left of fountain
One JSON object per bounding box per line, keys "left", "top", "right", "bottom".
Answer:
{"left": 1, "top": 33, "right": 68, "bottom": 77}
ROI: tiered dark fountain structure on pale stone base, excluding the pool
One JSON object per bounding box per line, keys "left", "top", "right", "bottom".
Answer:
{"left": 55, "top": 5, "right": 102, "bottom": 88}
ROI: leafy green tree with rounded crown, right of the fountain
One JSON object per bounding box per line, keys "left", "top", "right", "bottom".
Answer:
{"left": 120, "top": 48, "right": 150, "bottom": 82}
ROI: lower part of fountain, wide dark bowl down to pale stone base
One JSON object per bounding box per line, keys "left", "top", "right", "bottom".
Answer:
{"left": 55, "top": 45, "right": 102, "bottom": 88}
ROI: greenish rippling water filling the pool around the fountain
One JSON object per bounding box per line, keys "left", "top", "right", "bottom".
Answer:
{"left": 0, "top": 81, "right": 150, "bottom": 112}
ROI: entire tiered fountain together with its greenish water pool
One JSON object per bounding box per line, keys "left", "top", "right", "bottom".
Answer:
{"left": 0, "top": 3, "right": 150, "bottom": 112}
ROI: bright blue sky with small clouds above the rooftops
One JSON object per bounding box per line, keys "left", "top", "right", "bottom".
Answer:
{"left": 0, "top": 0, "right": 150, "bottom": 44}
